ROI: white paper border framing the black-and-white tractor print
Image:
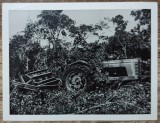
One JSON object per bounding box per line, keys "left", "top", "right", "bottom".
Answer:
{"left": 2, "top": 2, "right": 158, "bottom": 121}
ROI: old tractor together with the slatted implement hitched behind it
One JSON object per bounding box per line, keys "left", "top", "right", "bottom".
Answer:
{"left": 14, "top": 59, "right": 141, "bottom": 92}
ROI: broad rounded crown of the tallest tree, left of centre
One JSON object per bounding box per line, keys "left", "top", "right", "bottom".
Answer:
{"left": 38, "top": 10, "right": 74, "bottom": 50}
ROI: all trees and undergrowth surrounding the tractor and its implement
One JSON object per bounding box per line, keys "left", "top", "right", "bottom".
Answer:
{"left": 9, "top": 10, "right": 151, "bottom": 114}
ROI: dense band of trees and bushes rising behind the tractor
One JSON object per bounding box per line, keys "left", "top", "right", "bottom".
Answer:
{"left": 10, "top": 10, "right": 151, "bottom": 79}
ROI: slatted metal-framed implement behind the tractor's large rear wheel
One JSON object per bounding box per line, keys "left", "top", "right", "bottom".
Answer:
{"left": 14, "top": 69, "right": 62, "bottom": 90}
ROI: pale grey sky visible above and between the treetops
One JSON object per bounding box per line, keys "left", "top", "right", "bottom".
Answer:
{"left": 9, "top": 9, "right": 138, "bottom": 44}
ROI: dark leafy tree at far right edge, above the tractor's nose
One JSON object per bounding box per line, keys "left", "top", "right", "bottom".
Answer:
{"left": 131, "top": 9, "right": 151, "bottom": 60}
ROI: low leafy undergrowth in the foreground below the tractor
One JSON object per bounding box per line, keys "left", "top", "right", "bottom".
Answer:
{"left": 10, "top": 81, "right": 151, "bottom": 114}
